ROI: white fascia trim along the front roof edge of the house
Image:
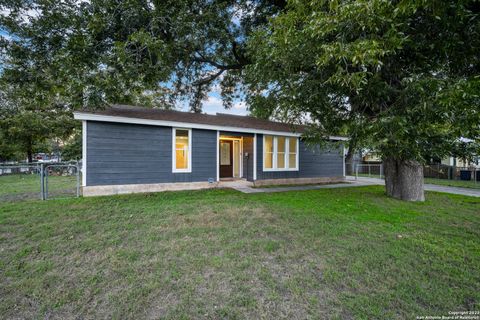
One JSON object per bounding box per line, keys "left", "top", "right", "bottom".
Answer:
{"left": 73, "top": 112, "right": 348, "bottom": 141}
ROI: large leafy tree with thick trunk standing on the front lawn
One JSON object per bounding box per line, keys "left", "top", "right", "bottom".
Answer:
{"left": 246, "top": 0, "right": 480, "bottom": 200}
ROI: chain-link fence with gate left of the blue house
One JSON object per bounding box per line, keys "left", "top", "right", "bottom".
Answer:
{"left": 0, "top": 162, "right": 81, "bottom": 201}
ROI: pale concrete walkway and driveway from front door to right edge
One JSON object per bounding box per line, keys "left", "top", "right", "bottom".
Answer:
{"left": 228, "top": 176, "right": 480, "bottom": 197}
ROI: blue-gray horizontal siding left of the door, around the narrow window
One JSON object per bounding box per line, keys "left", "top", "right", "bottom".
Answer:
{"left": 87, "top": 121, "right": 216, "bottom": 186}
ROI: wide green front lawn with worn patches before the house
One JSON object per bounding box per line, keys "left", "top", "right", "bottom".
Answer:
{"left": 0, "top": 186, "right": 480, "bottom": 319}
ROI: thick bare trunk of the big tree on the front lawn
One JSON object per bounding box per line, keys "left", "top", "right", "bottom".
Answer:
{"left": 383, "top": 158, "right": 425, "bottom": 201}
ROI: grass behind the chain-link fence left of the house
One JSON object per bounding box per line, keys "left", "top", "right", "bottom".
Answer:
{"left": 0, "top": 174, "right": 77, "bottom": 200}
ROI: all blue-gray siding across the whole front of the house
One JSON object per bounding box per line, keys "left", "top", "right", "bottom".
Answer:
{"left": 86, "top": 121, "right": 343, "bottom": 186}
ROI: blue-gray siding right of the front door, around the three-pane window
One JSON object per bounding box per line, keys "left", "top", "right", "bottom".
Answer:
{"left": 257, "top": 134, "right": 343, "bottom": 180}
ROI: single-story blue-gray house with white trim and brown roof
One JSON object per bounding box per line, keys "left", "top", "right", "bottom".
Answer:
{"left": 74, "top": 105, "right": 346, "bottom": 196}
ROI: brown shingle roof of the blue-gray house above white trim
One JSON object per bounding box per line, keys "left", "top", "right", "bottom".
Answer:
{"left": 77, "top": 105, "right": 306, "bottom": 133}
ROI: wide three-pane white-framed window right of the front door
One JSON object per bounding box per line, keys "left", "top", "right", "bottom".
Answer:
{"left": 263, "top": 135, "right": 298, "bottom": 171}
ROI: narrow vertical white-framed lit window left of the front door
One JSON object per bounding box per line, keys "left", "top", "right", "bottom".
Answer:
{"left": 172, "top": 128, "right": 192, "bottom": 172}
